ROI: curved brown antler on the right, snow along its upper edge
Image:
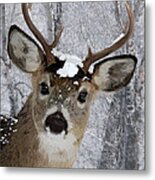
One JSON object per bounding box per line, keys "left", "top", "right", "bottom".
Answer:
{"left": 83, "top": 2, "right": 134, "bottom": 73}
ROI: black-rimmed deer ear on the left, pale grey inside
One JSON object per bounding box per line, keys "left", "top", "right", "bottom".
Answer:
{"left": 8, "top": 25, "right": 44, "bottom": 73}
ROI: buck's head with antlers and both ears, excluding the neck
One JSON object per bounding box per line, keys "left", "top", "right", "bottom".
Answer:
{"left": 8, "top": 3, "right": 137, "bottom": 167}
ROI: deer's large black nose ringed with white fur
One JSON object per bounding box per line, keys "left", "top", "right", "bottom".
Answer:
{"left": 45, "top": 112, "right": 68, "bottom": 134}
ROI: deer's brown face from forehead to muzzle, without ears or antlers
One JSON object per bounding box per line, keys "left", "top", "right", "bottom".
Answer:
{"left": 33, "top": 71, "right": 96, "bottom": 141}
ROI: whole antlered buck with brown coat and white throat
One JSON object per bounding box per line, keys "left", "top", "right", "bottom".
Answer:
{"left": 0, "top": 2, "right": 137, "bottom": 168}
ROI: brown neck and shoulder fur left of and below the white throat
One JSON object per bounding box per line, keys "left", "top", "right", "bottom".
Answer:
{"left": 0, "top": 93, "right": 79, "bottom": 168}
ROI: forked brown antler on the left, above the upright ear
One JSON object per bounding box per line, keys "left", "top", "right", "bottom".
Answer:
{"left": 22, "top": 3, "right": 63, "bottom": 63}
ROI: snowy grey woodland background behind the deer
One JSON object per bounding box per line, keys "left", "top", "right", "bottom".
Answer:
{"left": 0, "top": 0, "right": 145, "bottom": 169}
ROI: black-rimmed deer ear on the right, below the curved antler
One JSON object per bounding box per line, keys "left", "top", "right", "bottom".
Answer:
{"left": 92, "top": 55, "right": 137, "bottom": 91}
